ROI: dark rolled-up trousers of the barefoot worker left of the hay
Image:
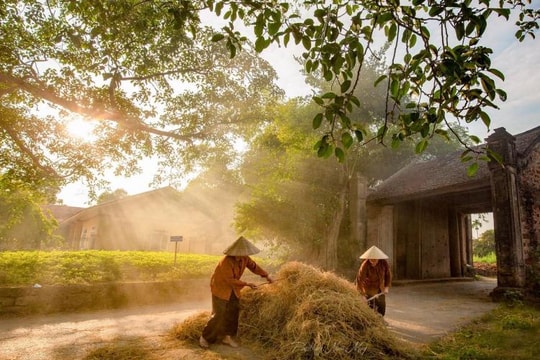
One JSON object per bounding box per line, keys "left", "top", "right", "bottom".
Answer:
{"left": 202, "top": 291, "right": 240, "bottom": 344}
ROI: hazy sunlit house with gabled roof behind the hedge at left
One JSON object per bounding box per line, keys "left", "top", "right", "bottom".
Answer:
{"left": 54, "top": 187, "right": 235, "bottom": 254}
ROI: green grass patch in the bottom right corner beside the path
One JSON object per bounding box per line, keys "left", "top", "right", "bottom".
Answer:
{"left": 422, "top": 304, "right": 540, "bottom": 360}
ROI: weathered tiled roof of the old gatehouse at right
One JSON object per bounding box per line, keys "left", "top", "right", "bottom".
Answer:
{"left": 368, "top": 127, "right": 540, "bottom": 201}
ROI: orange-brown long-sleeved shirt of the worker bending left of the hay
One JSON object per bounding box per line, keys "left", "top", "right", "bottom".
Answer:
{"left": 210, "top": 256, "right": 268, "bottom": 300}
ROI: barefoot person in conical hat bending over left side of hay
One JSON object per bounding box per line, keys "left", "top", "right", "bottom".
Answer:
{"left": 199, "top": 236, "right": 273, "bottom": 349}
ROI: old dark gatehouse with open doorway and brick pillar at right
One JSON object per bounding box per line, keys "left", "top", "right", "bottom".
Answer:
{"left": 364, "top": 127, "right": 540, "bottom": 291}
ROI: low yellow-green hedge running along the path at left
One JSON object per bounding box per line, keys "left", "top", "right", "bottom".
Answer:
{"left": 0, "top": 250, "right": 272, "bottom": 286}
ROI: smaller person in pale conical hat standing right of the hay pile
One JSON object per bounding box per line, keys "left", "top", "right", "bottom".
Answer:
{"left": 356, "top": 246, "right": 392, "bottom": 316}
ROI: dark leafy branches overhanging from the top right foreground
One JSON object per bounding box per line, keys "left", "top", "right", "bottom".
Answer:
{"left": 207, "top": 0, "right": 540, "bottom": 175}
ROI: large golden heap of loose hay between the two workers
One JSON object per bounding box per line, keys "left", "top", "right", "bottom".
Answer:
{"left": 176, "top": 262, "right": 412, "bottom": 360}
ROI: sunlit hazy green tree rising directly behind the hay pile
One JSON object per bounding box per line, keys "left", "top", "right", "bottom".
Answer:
{"left": 235, "top": 99, "right": 343, "bottom": 268}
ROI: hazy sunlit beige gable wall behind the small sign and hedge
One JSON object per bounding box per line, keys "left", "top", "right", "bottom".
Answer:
{"left": 64, "top": 196, "right": 235, "bottom": 254}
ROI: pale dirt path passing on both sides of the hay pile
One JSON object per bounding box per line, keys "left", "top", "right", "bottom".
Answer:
{"left": 0, "top": 279, "right": 496, "bottom": 360}
